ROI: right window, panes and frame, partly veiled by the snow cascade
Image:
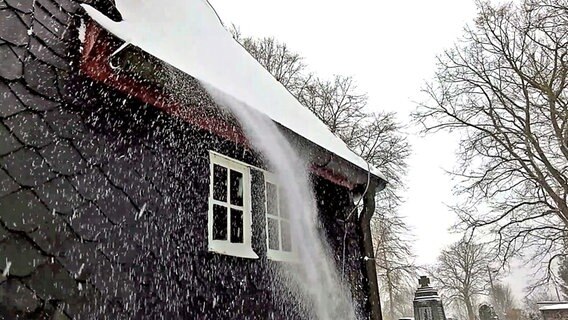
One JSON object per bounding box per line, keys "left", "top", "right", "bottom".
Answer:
{"left": 264, "top": 172, "right": 296, "bottom": 261}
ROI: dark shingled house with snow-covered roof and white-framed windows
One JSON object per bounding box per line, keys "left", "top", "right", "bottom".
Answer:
{"left": 0, "top": 0, "right": 386, "bottom": 319}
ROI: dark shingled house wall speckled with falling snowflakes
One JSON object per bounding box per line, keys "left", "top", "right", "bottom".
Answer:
{"left": 0, "top": 0, "right": 365, "bottom": 319}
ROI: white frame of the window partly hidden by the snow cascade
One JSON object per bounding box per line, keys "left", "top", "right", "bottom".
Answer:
{"left": 264, "top": 171, "right": 298, "bottom": 262}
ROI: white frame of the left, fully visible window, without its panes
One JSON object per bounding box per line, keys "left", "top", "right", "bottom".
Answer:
{"left": 207, "top": 151, "right": 258, "bottom": 259}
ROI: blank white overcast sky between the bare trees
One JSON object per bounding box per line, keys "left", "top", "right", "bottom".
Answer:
{"left": 209, "top": 0, "right": 522, "bottom": 300}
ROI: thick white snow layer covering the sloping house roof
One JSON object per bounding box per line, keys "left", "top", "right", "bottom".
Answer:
{"left": 83, "top": 0, "right": 385, "bottom": 179}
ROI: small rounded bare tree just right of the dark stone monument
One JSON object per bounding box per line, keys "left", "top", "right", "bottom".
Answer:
{"left": 430, "top": 238, "right": 491, "bottom": 320}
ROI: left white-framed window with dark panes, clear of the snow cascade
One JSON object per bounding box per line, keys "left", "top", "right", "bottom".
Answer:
{"left": 207, "top": 152, "right": 258, "bottom": 259}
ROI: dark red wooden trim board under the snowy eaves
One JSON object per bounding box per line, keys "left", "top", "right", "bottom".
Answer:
{"left": 81, "top": 20, "right": 354, "bottom": 189}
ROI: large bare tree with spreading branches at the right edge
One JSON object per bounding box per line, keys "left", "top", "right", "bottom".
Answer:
{"left": 414, "top": 0, "right": 568, "bottom": 276}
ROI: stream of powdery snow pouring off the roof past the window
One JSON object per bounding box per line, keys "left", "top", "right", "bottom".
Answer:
{"left": 203, "top": 84, "right": 355, "bottom": 319}
